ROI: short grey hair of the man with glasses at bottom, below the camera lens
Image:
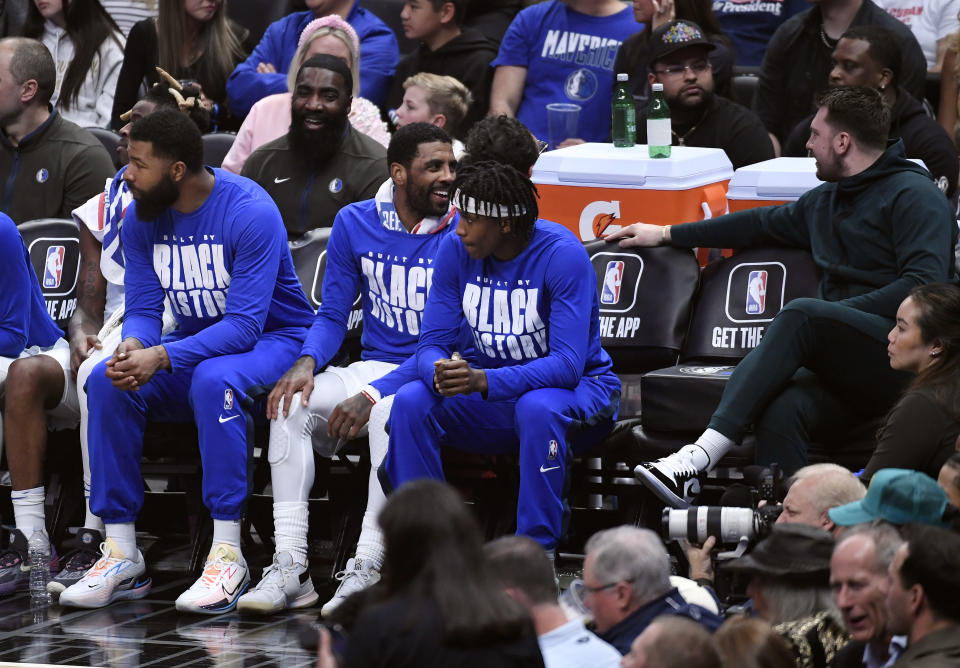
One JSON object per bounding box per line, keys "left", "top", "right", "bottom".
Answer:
{"left": 586, "top": 526, "right": 670, "bottom": 603}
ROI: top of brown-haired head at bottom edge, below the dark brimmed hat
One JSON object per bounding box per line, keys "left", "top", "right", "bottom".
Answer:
{"left": 713, "top": 615, "right": 796, "bottom": 668}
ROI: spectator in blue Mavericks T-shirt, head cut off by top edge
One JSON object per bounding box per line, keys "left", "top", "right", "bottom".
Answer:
{"left": 490, "top": 0, "right": 637, "bottom": 142}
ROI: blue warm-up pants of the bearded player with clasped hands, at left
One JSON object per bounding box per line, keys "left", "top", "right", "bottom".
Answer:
{"left": 87, "top": 328, "right": 306, "bottom": 524}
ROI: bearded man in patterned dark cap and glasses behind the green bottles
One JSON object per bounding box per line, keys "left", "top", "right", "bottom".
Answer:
{"left": 637, "top": 21, "right": 774, "bottom": 169}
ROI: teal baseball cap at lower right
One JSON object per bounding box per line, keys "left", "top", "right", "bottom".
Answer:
{"left": 829, "top": 469, "right": 957, "bottom": 527}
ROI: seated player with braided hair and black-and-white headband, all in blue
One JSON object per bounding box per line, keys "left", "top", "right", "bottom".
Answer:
{"left": 381, "top": 161, "right": 620, "bottom": 555}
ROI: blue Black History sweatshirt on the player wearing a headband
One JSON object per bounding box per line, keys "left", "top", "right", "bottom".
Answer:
{"left": 417, "top": 220, "right": 620, "bottom": 400}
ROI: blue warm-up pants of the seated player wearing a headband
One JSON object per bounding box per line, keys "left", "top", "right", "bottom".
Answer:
{"left": 384, "top": 374, "right": 620, "bottom": 550}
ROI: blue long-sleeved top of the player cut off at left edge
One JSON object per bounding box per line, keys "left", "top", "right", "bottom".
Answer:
{"left": 0, "top": 213, "right": 63, "bottom": 357}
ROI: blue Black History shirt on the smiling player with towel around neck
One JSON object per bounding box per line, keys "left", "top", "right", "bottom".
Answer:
{"left": 301, "top": 199, "right": 459, "bottom": 376}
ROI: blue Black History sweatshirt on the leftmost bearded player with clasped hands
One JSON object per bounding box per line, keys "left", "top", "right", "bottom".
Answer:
{"left": 120, "top": 169, "right": 313, "bottom": 369}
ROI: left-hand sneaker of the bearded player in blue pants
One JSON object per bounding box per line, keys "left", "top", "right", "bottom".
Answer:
{"left": 60, "top": 538, "right": 151, "bottom": 608}
